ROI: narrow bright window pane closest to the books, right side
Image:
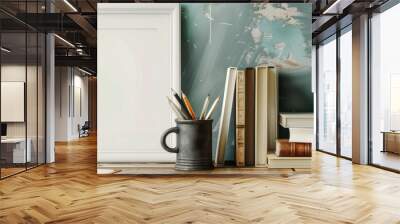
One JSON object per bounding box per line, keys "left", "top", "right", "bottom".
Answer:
{"left": 318, "top": 39, "right": 336, "bottom": 153}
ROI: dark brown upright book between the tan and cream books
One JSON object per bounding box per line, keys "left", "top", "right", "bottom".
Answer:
{"left": 244, "top": 68, "right": 255, "bottom": 166}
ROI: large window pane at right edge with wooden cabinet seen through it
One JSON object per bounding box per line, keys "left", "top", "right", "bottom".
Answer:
{"left": 371, "top": 4, "right": 400, "bottom": 170}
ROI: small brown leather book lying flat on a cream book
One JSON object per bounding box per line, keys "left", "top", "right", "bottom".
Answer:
{"left": 275, "top": 139, "right": 312, "bottom": 157}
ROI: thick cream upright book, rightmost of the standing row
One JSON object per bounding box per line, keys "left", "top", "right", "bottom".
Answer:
{"left": 255, "top": 66, "right": 278, "bottom": 167}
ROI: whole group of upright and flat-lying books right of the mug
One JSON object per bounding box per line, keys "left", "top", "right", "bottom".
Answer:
{"left": 215, "top": 66, "right": 314, "bottom": 168}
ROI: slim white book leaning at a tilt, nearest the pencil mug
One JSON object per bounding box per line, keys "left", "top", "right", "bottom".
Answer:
{"left": 214, "top": 67, "right": 237, "bottom": 167}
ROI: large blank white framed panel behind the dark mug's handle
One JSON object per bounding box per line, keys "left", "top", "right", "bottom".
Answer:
{"left": 97, "top": 3, "right": 180, "bottom": 162}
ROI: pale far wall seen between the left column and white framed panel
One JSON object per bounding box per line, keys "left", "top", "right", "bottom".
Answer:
{"left": 55, "top": 67, "right": 88, "bottom": 141}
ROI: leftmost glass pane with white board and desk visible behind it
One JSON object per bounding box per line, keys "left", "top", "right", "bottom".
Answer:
{"left": 0, "top": 32, "right": 30, "bottom": 178}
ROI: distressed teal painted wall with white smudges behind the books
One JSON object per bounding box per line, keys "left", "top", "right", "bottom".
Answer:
{"left": 181, "top": 3, "right": 313, "bottom": 160}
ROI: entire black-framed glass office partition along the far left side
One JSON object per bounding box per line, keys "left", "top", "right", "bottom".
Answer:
{"left": 0, "top": 1, "right": 46, "bottom": 178}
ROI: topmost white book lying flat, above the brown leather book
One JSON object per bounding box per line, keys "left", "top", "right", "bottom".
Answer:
{"left": 279, "top": 113, "right": 314, "bottom": 128}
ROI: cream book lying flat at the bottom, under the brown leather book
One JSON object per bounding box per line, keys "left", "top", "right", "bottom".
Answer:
{"left": 268, "top": 154, "right": 312, "bottom": 169}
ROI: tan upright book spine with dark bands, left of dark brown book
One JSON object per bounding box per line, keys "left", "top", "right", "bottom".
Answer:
{"left": 236, "top": 70, "right": 246, "bottom": 167}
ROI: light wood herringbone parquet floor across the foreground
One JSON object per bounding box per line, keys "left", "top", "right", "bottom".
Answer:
{"left": 0, "top": 137, "right": 400, "bottom": 224}
